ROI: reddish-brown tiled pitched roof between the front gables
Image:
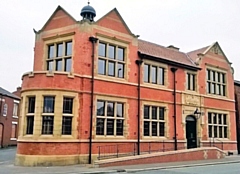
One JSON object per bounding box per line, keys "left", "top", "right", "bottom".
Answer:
{"left": 138, "top": 39, "right": 199, "bottom": 68}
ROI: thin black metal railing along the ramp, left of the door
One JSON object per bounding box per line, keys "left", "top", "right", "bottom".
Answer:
{"left": 97, "top": 141, "right": 185, "bottom": 160}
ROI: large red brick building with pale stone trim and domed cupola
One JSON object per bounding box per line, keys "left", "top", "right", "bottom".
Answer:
{"left": 16, "top": 3, "right": 237, "bottom": 166}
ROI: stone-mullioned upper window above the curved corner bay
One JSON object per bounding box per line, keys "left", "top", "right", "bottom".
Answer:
{"left": 46, "top": 41, "right": 72, "bottom": 72}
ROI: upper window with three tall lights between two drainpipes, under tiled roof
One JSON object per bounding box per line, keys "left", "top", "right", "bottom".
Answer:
{"left": 144, "top": 64, "right": 164, "bottom": 85}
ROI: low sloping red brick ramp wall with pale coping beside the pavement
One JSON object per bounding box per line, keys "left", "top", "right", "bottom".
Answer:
{"left": 94, "top": 147, "right": 225, "bottom": 167}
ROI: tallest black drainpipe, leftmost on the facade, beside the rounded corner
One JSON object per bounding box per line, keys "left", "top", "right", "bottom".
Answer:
{"left": 88, "top": 36, "right": 98, "bottom": 164}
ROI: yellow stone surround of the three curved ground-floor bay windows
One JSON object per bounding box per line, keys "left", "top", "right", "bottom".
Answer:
{"left": 19, "top": 90, "right": 79, "bottom": 141}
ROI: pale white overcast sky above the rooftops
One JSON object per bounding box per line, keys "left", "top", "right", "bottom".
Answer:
{"left": 0, "top": 0, "right": 240, "bottom": 91}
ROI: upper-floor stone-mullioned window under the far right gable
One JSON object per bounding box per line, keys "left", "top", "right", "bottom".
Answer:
{"left": 207, "top": 69, "right": 227, "bottom": 96}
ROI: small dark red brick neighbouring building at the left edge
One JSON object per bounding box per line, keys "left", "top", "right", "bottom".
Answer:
{"left": 0, "top": 87, "right": 20, "bottom": 148}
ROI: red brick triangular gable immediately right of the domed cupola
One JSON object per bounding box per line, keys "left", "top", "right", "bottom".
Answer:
{"left": 96, "top": 8, "right": 132, "bottom": 35}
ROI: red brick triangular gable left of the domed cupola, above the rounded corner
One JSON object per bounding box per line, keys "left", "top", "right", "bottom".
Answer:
{"left": 40, "top": 6, "right": 77, "bottom": 31}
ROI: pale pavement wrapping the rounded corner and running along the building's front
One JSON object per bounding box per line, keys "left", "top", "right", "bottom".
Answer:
{"left": 0, "top": 148, "right": 240, "bottom": 174}
